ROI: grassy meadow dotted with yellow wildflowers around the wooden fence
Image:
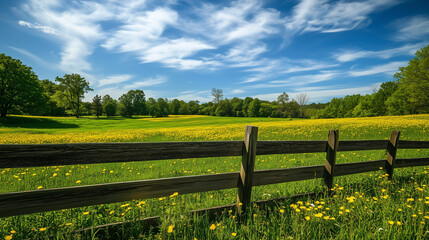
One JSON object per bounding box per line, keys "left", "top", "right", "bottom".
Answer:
{"left": 0, "top": 115, "right": 429, "bottom": 239}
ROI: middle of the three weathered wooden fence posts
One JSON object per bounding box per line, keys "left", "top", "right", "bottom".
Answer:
{"left": 323, "top": 130, "right": 340, "bottom": 189}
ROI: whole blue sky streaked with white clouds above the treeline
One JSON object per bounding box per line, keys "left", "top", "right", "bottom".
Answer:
{"left": 0, "top": 0, "right": 429, "bottom": 102}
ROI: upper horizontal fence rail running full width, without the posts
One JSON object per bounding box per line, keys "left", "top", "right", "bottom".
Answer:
{"left": 0, "top": 140, "right": 429, "bottom": 168}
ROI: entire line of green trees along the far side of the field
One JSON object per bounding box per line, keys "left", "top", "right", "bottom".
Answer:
{"left": 0, "top": 45, "right": 429, "bottom": 118}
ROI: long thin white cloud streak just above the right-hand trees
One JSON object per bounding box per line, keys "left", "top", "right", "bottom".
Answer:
{"left": 334, "top": 43, "right": 427, "bottom": 62}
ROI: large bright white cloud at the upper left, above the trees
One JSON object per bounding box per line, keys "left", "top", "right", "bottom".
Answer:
{"left": 20, "top": 0, "right": 114, "bottom": 73}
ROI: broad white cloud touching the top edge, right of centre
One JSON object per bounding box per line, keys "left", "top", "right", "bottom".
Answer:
{"left": 285, "top": 0, "right": 398, "bottom": 33}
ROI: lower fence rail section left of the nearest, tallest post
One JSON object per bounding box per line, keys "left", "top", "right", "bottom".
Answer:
{"left": 0, "top": 172, "right": 239, "bottom": 217}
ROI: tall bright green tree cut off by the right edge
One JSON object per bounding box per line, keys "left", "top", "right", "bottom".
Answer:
{"left": 391, "top": 45, "right": 429, "bottom": 113}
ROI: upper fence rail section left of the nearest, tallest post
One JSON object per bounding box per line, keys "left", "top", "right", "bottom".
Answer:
{"left": 0, "top": 141, "right": 243, "bottom": 168}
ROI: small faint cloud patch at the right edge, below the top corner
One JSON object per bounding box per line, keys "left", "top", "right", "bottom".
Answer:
{"left": 395, "top": 16, "right": 429, "bottom": 41}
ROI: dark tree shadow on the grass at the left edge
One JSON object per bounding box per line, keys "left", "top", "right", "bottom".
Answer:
{"left": 0, "top": 116, "right": 79, "bottom": 129}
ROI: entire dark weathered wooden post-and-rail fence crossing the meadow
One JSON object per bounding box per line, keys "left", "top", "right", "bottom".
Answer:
{"left": 0, "top": 126, "right": 429, "bottom": 217}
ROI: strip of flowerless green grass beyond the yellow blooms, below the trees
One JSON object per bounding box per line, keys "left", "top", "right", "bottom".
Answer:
{"left": 0, "top": 116, "right": 292, "bottom": 133}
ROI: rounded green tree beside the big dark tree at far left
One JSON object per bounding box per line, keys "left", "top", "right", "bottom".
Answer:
{"left": 54, "top": 73, "right": 93, "bottom": 118}
